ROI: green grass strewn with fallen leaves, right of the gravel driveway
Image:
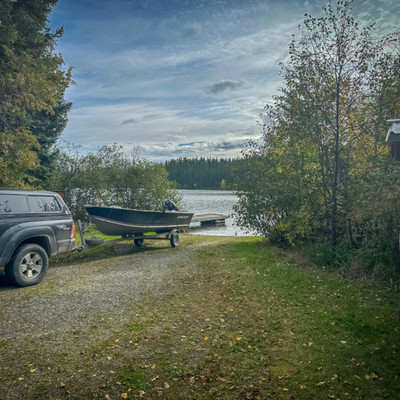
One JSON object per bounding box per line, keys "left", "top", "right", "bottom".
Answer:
{"left": 0, "top": 236, "right": 400, "bottom": 400}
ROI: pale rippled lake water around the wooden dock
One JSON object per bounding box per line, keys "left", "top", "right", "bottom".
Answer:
{"left": 179, "top": 190, "right": 251, "bottom": 236}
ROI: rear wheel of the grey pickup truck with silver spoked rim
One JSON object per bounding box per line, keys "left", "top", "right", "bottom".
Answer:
{"left": 5, "top": 244, "right": 49, "bottom": 286}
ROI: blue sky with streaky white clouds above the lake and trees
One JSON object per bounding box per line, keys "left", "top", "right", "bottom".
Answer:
{"left": 49, "top": 0, "right": 400, "bottom": 162}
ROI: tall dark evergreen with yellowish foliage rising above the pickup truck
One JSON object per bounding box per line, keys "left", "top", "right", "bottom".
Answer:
{"left": 0, "top": 0, "right": 71, "bottom": 187}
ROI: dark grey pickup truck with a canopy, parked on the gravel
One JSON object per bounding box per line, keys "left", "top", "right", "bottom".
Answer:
{"left": 0, "top": 189, "right": 75, "bottom": 286}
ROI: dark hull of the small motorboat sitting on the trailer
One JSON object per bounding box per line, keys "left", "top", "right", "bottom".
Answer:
{"left": 85, "top": 206, "right": 193, "bottom": 236}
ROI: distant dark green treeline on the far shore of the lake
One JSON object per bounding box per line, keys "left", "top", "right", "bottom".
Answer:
{"left": 165, "top": 157, "right": 239, "bottom": 189}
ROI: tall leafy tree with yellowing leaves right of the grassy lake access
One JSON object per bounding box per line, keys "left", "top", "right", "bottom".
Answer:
{"left": 234, "top": 1, "right": 400, "bottom": 272}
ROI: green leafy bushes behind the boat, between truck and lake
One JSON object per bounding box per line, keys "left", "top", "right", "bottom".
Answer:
{"left": 51, "top": 144, "right": 179, "bottom": 220}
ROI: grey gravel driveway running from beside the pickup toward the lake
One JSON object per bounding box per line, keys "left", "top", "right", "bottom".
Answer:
{"left": 0, "top": 236, "right": 238, "bottom": 400}
